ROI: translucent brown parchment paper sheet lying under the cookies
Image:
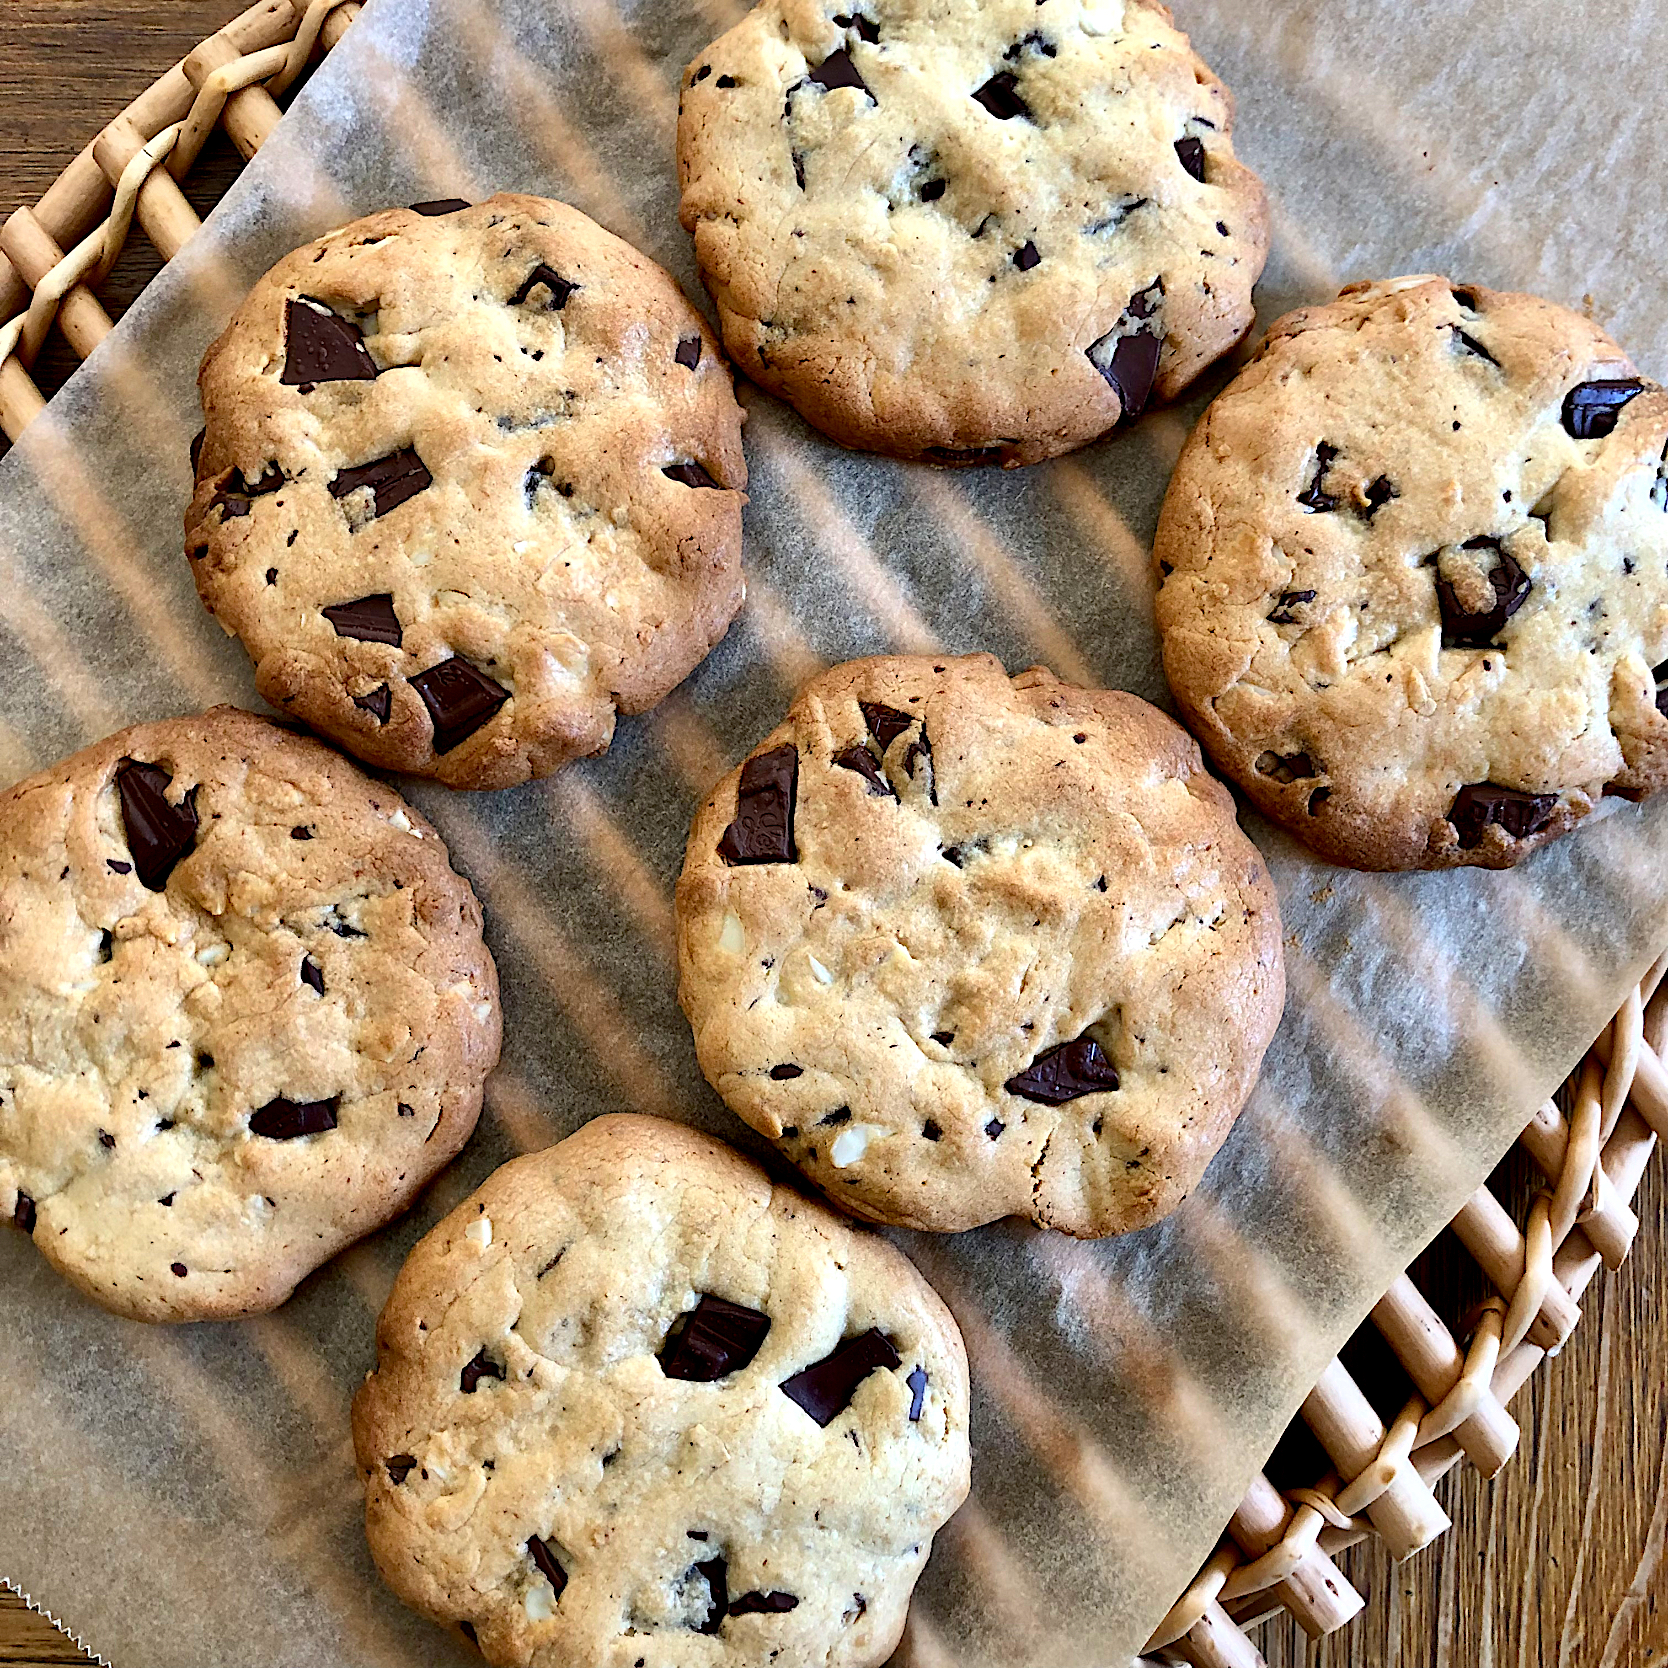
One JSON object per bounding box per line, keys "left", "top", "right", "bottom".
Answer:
{"left": 0, "top": 0, "right": 1668, "bottom": 1668}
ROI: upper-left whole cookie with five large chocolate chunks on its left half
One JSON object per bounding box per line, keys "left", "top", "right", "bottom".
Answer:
{"left": 185, "top": 195, "right": 747, "bottom": 787}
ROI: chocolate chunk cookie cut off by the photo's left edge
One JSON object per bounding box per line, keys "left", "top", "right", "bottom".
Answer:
{"left": 0, "top": 707, "right": 499, "bottom": 1321}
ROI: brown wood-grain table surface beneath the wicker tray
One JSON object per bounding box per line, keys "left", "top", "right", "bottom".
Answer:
{"left": 0, "top": 0, "right": 1668, "bottom": 1668}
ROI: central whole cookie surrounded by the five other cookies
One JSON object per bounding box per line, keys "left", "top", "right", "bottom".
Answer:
{"left": 677, "top": 654, "right": 1284, "bottom": 1238}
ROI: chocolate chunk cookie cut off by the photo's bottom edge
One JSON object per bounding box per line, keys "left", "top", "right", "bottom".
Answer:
{"left": 354, "top": 1116, "right": 969, "bottom": 1668}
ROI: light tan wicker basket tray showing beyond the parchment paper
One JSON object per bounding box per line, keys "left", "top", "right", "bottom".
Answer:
{"left": 0, "top": 0, "right": 1668, "bottom": 1668}
